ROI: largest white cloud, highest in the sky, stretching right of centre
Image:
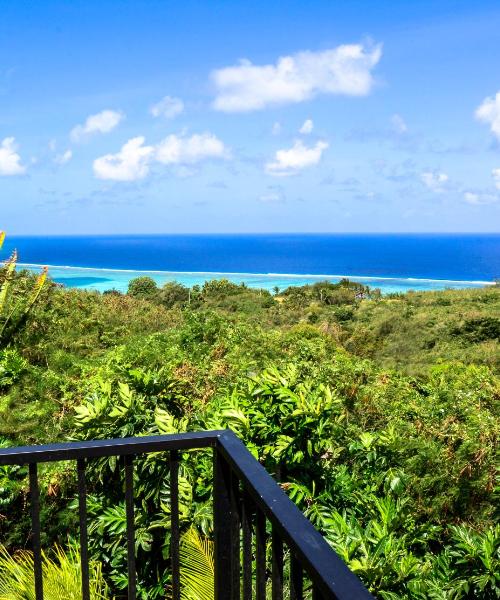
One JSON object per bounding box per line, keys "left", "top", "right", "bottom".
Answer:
{"left": 212, "top": 44, "right": 382, "bottom": 112}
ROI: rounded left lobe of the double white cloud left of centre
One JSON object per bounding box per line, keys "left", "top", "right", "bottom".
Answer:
{"left": 94, "top": 136, "right": 154, "bottom": 181}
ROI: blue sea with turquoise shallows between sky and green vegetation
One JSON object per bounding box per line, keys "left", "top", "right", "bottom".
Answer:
{"left": 2, "top": 234, "right": 500, "bottom": 292}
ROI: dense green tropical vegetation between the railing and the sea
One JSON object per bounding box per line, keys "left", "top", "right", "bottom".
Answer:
{"left": 0, "top": 241, "right": 500, "bottom": 600}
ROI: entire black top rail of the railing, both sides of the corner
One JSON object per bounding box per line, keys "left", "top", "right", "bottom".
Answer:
{"left": 0, "top": 429, "right": 373, "bottom": 600}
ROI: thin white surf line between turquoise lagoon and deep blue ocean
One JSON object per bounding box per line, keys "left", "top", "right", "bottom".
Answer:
{"left": 17, "top": 263, "right": 495, "bottom": 285}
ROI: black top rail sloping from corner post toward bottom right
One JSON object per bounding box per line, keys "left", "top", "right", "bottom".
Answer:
{"left": 217, "top": 430, "right": 373, "bottom": 600}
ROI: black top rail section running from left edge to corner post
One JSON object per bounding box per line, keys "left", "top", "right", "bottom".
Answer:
{"left": 0, "top": 431, "right": 223, "bottom": 465}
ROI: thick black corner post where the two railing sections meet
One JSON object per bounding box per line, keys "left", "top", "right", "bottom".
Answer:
{"left": 213, "top": 447, "right": 237, "bottom": 600}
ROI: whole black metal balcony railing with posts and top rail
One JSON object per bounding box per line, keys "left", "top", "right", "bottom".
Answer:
{"left": 0, "top": 430, "right": 372, "bottom": 600}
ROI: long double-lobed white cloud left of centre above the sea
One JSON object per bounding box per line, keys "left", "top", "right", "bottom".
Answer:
{"left": 94, "top": 133, "right": 229, "bottom": 181}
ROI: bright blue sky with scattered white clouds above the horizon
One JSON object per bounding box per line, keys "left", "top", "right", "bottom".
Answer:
{"left": 0, "top": 0, "right": 500, "bottom": 234}
